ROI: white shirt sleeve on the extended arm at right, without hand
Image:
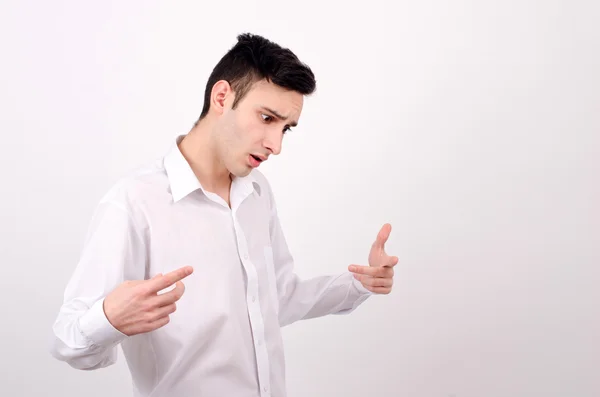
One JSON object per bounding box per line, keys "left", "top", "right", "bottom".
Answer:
{"left": 270, "top": 189, "right": 373, "bottom": 327}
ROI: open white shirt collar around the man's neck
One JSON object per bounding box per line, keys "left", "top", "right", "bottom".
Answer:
{"left": 163, "top": 135, "right": 260, "bottom": 202}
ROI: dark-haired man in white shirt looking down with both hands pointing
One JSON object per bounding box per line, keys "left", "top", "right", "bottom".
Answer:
{"left": 52, "top": 34, "right": 398, "bottom": 397}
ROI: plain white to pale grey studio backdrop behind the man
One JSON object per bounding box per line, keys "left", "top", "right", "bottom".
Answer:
{"left": 0, "top": 0, "right": 600, "bottom": 397}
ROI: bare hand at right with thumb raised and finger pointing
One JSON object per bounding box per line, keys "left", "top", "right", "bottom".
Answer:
{"left": 348, "top": 223, "right": 398, "bottom": 294}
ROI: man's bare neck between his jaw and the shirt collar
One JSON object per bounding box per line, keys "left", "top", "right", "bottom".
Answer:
{"left": 179, "top": 119, "right": 231, "bottom": 193}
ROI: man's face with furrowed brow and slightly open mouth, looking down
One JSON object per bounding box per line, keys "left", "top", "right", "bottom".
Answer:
{"left": 216, "top": 80, "right": 304, "bottom": 177}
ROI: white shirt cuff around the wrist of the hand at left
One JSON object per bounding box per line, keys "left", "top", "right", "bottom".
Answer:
{"left": 79, "top": 298, "right": 127, "bottom": 346}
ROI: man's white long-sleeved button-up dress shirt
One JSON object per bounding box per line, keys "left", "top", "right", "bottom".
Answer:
{"left": 51, "top": 136, "right": 372, "bottom": 397}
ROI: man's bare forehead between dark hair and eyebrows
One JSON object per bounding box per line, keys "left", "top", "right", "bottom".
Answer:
{"left": 244, "top": 80, "right": 304, "bottom": 118}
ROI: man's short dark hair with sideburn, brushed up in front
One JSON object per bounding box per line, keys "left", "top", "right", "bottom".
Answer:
{"left": 200, "top": 33, "right": 316, "bottom": 119}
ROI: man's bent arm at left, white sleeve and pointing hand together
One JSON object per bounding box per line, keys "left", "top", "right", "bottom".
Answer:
{"left": 50, "top": 201, "right": 193, "bottom": 370}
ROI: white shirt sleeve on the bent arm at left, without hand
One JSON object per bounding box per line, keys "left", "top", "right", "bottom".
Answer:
{"left": 50, "top": 201, "right": 145, "bottom": 370}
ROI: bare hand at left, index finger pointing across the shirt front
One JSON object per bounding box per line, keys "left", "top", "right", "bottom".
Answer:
{"left": 104, "top": 266, "right": 193, "bottom": 336}
